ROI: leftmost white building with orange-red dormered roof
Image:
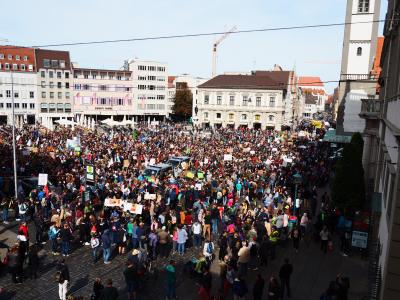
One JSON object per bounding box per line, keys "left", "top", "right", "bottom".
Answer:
{"left": 0, "top": 46, "right": 38, "bottom": 125}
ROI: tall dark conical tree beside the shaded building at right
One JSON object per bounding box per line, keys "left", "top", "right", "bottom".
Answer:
{"left": 332, "top": 133, "right": 365, "bottom": 216}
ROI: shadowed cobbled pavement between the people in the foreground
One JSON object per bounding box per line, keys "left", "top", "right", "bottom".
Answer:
{"left": 0, "top": 186, "right": 367, "bottom": 300}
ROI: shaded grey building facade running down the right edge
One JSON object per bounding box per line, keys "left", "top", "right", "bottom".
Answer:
{"left": 361, "top": 0, "right": 400, "bottom": 300}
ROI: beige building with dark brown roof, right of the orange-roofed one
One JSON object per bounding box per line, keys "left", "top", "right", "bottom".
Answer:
{"left": 35, "top": 49, "right": 74, "bottom": 121}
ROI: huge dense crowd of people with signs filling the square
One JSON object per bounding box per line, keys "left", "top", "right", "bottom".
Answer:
{"left": 0, "top": 125, "right": 345, "bottom": 300}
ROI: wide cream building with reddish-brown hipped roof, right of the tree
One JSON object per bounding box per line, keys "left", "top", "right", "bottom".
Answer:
{"left": 193, "top": 74, "right": 285, "bottom": 130}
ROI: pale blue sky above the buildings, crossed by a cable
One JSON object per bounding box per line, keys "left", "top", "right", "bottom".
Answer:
{"left": 0, "top": 0, "right": 386, "bottom": 91}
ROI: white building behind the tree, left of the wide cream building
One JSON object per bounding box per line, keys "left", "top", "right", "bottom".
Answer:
{"left": 168, "top": 74, "right": 208, "bottom": 116}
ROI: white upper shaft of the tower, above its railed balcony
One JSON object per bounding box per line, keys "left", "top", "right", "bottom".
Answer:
{"left": 340, "top": 0, "right": 381, "bottom": 80}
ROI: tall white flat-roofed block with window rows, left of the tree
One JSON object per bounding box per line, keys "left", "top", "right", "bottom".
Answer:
{"left": 129, "top": 59, "right": 170, "bottom": 120}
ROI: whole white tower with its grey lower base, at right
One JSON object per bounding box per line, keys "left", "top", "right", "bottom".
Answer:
{"left": 335, "top": 0, "right": 381, "bottom": 134}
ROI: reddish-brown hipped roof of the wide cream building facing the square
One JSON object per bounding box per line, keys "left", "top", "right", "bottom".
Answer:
{"left": 199, "top": 72, "right": 287, "bottom": 90}
